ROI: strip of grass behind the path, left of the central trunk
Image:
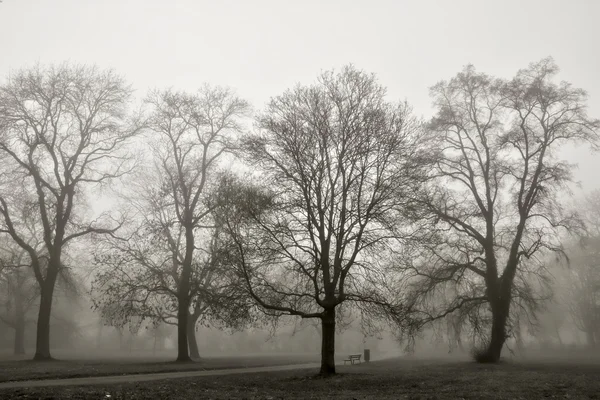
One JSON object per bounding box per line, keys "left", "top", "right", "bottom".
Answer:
{"left": 0, "top": 354, "right": 319, "bottom": 384}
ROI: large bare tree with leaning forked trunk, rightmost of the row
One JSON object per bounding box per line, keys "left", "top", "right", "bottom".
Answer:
{"left": 407, "top": 59, "right": 600, "bottom": 362}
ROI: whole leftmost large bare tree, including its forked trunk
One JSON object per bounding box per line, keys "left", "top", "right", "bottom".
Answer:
{"left": 0, "top": 65, "right": 139, "bottom": 360}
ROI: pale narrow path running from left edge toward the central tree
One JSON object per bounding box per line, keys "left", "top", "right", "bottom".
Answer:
{"left": 0, "top": 363, "right": 320, "bottom": 389}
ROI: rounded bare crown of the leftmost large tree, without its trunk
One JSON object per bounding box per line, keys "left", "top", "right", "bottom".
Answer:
{"left": 1, "top": 65, "right": 134, "bottom": 186}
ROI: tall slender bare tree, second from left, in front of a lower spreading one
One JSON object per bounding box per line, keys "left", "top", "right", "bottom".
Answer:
{"left": 101, "top": 86, "right": 249, "bottom": 361}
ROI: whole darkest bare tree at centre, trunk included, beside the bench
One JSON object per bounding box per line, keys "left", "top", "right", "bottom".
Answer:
{"left": 222, "top": 67, "right": 420, "bottom": 375}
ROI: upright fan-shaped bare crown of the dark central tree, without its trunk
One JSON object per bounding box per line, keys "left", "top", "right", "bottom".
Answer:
{"left": 241, "top": 68, "right": 416, "bottom": 313}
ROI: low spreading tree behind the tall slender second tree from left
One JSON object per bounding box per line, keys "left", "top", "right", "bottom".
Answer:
{"left": 92, "top": 215, "right": 249, "bottom": 359}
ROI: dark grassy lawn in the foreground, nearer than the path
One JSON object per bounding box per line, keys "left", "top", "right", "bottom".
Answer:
{"left": 0, "top": 359, "right": 600, "bottom": 399}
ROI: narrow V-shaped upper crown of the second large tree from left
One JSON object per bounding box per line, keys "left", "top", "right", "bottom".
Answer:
{"left": 146, "top": 86, "right": 249, "bottom": 225}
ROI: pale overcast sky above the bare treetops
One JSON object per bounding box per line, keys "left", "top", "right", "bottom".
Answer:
{"left": 0, "top": 0, "right": 600, "bottom": 194}
